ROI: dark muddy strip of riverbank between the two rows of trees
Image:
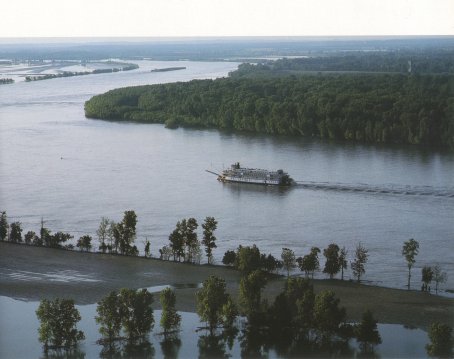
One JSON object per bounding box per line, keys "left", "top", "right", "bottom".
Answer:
{"left": 0, "top": 242, "right": 454, "bottom": 328}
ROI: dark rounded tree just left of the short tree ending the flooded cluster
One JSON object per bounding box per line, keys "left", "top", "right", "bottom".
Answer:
{"left": 314, "top": 290, "right": 346, "bottom": 343}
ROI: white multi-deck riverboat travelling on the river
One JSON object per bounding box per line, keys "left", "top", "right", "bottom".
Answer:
{"left": 218, "top": 162, "right": 294, "bottom": 186}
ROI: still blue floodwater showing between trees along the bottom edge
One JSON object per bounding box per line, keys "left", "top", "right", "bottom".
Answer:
{"left": 0, "top": 296, "right": 428, "bottom": 359}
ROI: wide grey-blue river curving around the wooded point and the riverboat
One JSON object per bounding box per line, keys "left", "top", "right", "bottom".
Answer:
{"left": 0, "top": 61, "right": 454, "bottom": 289}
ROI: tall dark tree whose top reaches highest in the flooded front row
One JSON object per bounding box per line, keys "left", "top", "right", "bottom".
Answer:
{"left": 239, "top": 270, "right": 266, "bottom": 325}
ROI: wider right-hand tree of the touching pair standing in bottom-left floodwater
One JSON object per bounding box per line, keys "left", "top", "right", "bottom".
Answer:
{"left": 120, "top": 288, "right": 154, "bottom": 341}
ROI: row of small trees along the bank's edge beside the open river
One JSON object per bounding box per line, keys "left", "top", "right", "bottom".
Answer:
{"left": 0, "top": 210, "right": 447, "bottom": 294}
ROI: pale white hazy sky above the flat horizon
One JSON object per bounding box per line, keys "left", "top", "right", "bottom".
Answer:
{"left": 0, "top": 0, "right": 454, "bottom": 37}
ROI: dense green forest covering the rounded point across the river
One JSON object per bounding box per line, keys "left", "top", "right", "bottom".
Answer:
{"left": 85, "top": 70, "right": 454, "bottom": 148}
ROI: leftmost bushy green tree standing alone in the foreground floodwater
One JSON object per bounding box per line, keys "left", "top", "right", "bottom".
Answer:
{"left": 36, "top": 298, "right": 85, "bottom": 352}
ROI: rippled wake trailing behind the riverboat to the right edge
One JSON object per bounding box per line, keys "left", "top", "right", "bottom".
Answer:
{"left": 295, "top": 181, "right": 454, "bottom": 199}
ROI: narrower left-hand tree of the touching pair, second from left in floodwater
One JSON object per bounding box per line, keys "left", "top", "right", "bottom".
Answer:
{"left": 95, "top": 291, "right": 123, "bottom": 348}
